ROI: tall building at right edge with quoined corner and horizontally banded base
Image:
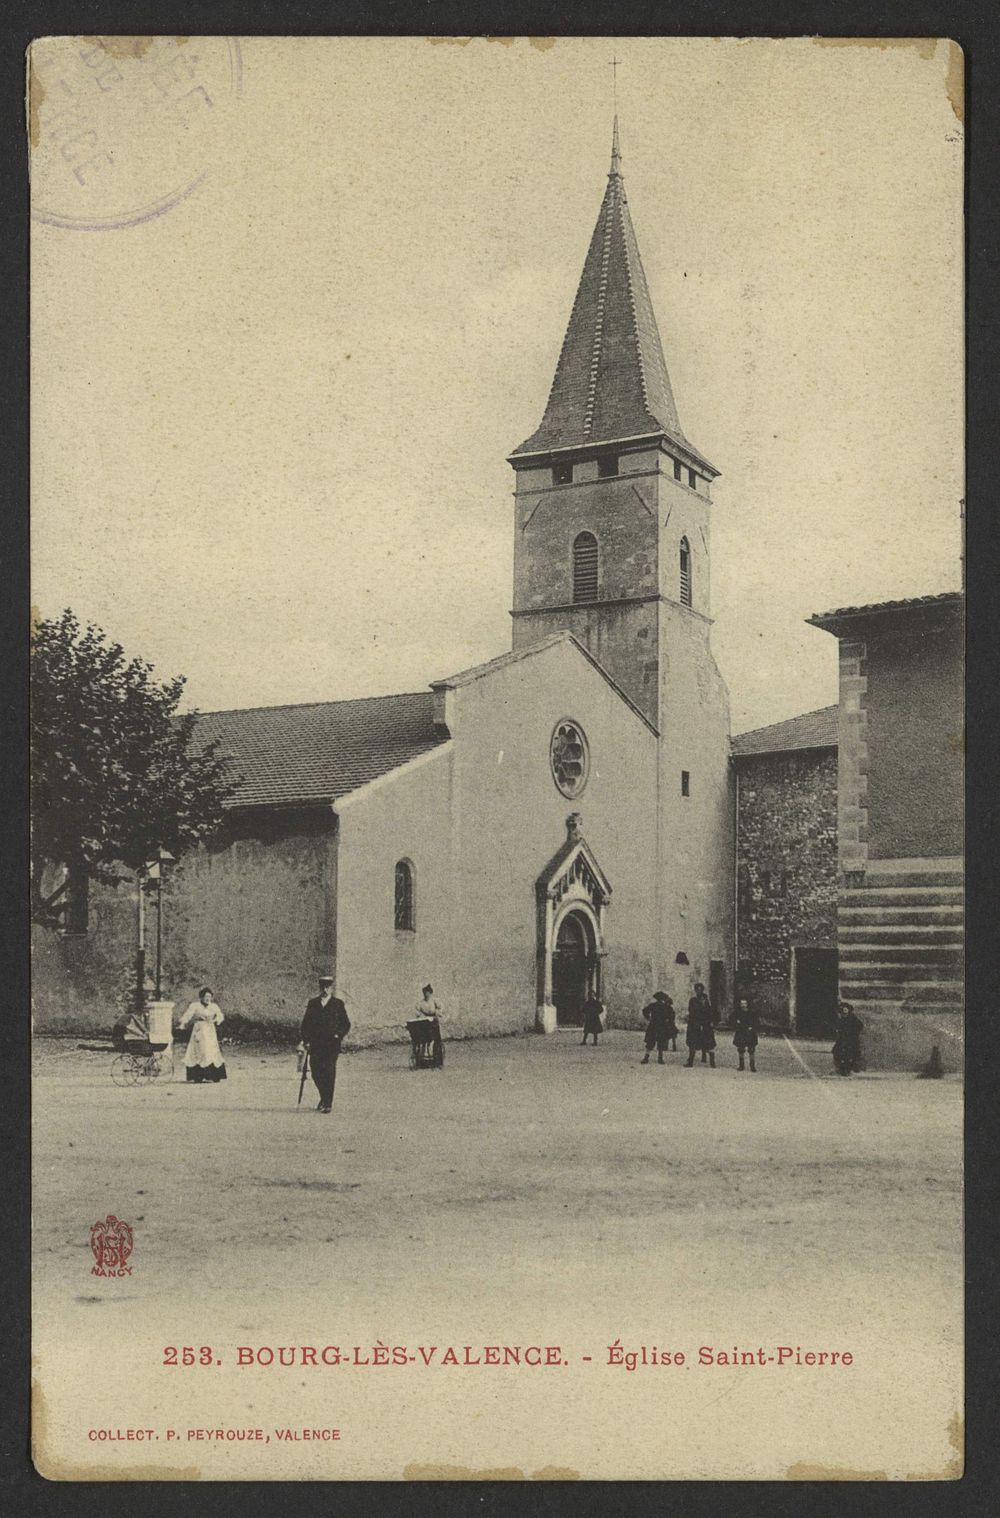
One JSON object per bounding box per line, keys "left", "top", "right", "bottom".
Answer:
{"left": 810, "top": 591, "right": 965, "bottom": 1067}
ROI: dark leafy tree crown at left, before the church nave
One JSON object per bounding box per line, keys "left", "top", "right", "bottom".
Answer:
{"left": 30, "top": 610, "right": 237, "bottom": 926}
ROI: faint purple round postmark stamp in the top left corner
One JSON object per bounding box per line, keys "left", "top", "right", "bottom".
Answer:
{"left": 27, "top": 36, "right": 243, "bottom": 232}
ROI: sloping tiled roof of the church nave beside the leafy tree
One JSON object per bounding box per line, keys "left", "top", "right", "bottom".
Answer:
{"left": 194, "top": 691, "right": 446, "bottom": 806}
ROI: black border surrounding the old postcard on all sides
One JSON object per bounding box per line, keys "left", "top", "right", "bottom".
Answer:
{"left": 0, "top": 0, "right": 1000, "bottom": 1518}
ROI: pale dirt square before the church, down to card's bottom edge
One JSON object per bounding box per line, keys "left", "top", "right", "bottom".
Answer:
{"left": 33, "top": 1032, "right": 962, "bottom": 1480}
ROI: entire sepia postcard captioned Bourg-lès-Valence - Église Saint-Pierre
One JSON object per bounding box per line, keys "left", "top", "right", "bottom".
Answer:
{"left": 27, "top": 36, "right": 965, "bottom": 1482}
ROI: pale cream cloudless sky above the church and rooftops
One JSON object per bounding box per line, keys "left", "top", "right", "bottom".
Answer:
{"left": 32, "top": 38, "right": 964, "bottom": 732}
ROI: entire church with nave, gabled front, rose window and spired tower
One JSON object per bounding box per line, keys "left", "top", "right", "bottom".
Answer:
{"left": 36, "top": 124, "right": 734, "bottom": 1041}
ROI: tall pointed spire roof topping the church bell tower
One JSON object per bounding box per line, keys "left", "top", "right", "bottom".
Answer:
{"left": 510, "top": 117, "right": 718, "bottom": 475}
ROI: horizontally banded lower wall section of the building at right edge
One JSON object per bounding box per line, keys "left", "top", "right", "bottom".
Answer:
{"left": 838, "top": 859, "right": 965, "bottom": 1019}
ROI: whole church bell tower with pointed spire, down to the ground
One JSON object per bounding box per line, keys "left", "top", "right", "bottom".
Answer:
{"left": 510, "top": 118, "right": 733, "bottom": 995}
